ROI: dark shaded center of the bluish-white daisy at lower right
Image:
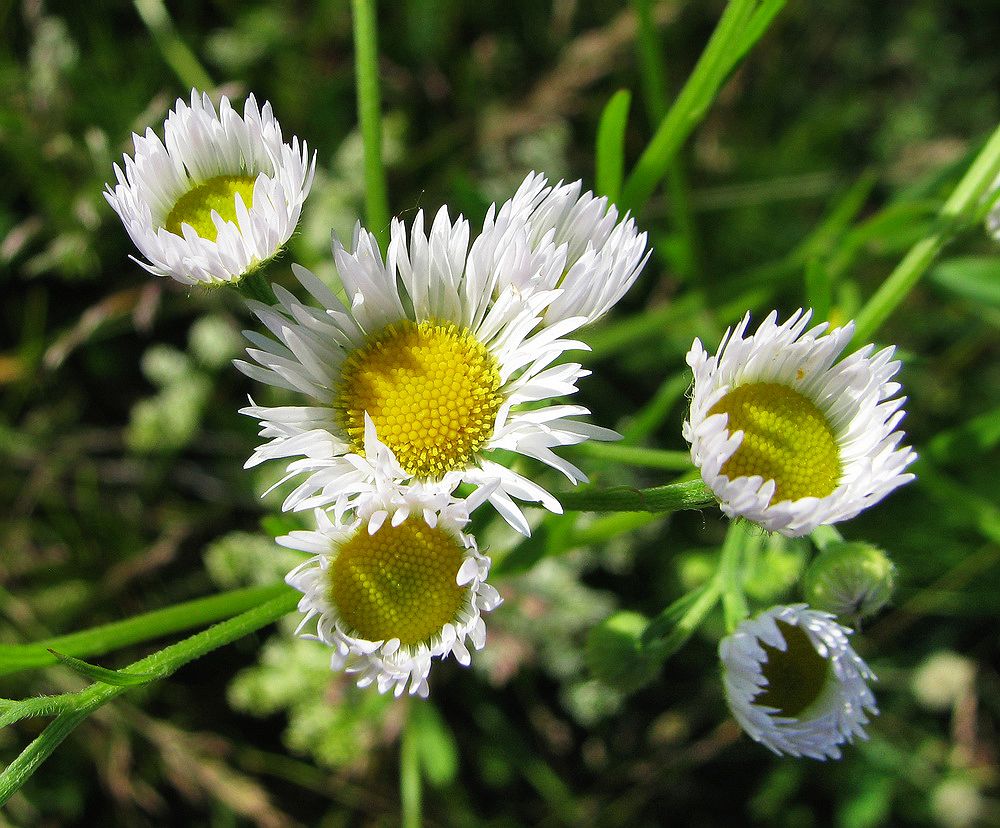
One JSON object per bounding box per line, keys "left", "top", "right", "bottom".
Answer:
{"left": 753, "top": 621, "right": 830, "bottom": 718}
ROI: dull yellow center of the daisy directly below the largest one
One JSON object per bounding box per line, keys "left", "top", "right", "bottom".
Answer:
{"left": 329, "top": 519, "right": 468, "bottom": 645}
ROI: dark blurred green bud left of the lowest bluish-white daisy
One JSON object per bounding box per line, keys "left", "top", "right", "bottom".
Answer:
{"left": 585, "top": 611, "right": 660, "bottom": 693}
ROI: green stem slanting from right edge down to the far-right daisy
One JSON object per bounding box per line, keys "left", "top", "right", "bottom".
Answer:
{"left": 852, "top": 120, "right": 1000, "bottom": 346}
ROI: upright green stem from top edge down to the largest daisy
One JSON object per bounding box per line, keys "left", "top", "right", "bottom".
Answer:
{"left": 351, "top": 0, "right": 389, "bottom": 251}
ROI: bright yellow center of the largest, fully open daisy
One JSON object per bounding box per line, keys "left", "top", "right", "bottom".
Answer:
{"left": 334, "top": 321, "right": 503, "bottom": 478}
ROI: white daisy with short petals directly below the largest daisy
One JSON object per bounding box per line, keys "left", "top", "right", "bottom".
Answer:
{"left": 278, "top": 488, "right": 501, "bottom": 697}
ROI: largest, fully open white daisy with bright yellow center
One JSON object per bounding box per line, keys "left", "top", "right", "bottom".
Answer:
{"left": 237, "top": 208, "right": 618, "bottom": 534}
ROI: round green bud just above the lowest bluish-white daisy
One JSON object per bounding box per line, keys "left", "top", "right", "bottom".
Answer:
{"left": 802, "top": 541, "right": 896, "bottom": 618}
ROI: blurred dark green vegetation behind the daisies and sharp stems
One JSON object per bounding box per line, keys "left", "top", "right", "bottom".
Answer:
{"left": 0, "top": 0, "right": 1000, "bottom": 828}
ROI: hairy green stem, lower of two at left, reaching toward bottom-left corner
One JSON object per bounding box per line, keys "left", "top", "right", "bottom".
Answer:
{"left": 0, "top": 585, "right": 299, "bottom": 805}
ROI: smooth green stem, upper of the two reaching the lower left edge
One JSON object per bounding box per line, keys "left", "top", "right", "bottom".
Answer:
{"left": 0, "top": 583, "right": 288, "bottom": 675}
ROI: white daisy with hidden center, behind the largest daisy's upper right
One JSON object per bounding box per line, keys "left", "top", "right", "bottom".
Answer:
{"left": 483, "top": 173, "right": 650, "bottom": 325}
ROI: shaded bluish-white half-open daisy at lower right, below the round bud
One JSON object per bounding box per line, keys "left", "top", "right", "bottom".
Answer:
{"left": 719, "top": 604, "right": 878, "bottom": 759}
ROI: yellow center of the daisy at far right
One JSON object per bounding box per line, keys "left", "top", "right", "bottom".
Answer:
{"left": 709, "top": 382, "right": 840, "bottom": 503}
